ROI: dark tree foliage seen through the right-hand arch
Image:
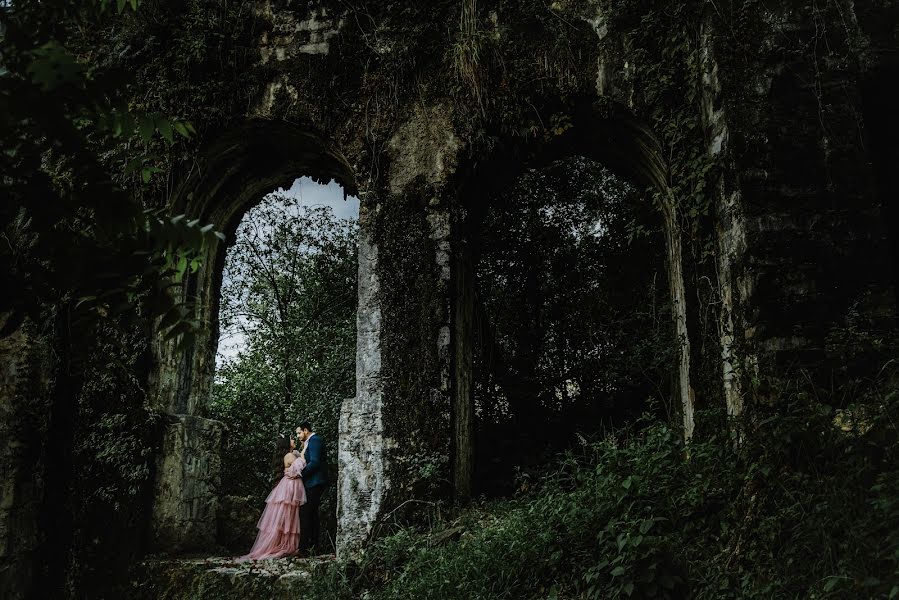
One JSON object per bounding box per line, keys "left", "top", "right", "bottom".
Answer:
{"left": 477, "top": 157, "right": 675, "bottom": 420}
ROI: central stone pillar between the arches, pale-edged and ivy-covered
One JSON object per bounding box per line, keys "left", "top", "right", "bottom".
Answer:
{"left": 337, "top": 105, "right": 460, "bottom": 554}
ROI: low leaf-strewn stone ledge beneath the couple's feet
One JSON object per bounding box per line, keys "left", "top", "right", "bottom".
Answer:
{"left": 135, "top": 554, "right": 335, "bottom": 600}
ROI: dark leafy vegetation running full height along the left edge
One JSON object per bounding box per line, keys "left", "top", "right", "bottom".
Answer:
{"left": 0, "top": 0, "right": 220, "bottom": 597}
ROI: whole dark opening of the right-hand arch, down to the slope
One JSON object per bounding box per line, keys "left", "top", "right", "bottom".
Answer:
{"left": 472, "top": 156, "right": 676, "bottom": 495}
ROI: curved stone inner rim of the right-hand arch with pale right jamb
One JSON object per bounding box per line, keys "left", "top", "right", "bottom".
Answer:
{"left": 452, "top": 98, "right": 694, "bottom": 498}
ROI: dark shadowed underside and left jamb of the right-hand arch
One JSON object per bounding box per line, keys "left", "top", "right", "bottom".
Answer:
{"left": 452, "top": 97, "right": 676, "bottom": 499}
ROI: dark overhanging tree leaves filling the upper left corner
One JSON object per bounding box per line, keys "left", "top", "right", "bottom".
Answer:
{"left": 0, "top": 1, "right": 216, "bottom": 346}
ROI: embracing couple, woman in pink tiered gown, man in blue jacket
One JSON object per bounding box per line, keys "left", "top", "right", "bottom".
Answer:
{"left": 238, "top": 422, "right": 328, "bottom": 560}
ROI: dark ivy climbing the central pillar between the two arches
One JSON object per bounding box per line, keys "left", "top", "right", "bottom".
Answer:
{"left": 371, "top": 190, "right": 450, "bottom": 498}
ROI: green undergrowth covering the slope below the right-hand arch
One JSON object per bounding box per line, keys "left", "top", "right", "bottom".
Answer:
{"left": 313, "top": 390, "right": 899, "bottom": 599}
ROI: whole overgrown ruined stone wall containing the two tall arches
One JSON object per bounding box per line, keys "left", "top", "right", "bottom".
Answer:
{"left": 0, "top": 0, "right": 897, "bottom": 596}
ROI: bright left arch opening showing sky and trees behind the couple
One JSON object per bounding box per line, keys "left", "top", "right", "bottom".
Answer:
{"left": 209, "top": 177, "right": 359, "bottom": 552}
